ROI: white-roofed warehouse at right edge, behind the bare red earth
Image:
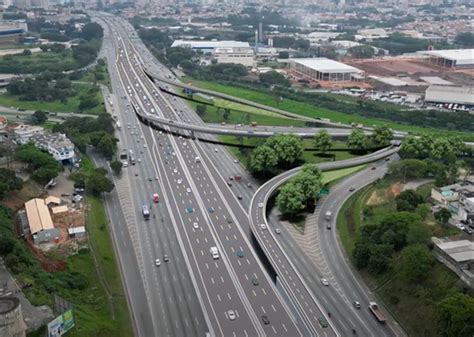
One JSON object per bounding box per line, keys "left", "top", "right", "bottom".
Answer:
{"left": 417, "top": 49, "right": 474, "bottom": 68}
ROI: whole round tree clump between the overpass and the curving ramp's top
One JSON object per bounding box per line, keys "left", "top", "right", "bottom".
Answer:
{"left": 249, "top": 134, "right": 304, "bottom": 175}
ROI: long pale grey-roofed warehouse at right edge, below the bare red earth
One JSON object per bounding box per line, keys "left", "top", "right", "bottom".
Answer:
{"left": 425, "top": 85, "right": 474, "bottom": 106}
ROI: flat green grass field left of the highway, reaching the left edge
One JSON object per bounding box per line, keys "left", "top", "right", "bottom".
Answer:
{"left": 0, "top": 84, "right": 105, "bottom": 114}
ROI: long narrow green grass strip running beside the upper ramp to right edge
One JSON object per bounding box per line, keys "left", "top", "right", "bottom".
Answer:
{"left": 185, "top": 78, "right": 474, "bottom": 140}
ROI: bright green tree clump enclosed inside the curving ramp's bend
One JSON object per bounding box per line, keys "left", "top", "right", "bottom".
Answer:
{"left": 276, "top": 164, "right": 321, "bottom": 217}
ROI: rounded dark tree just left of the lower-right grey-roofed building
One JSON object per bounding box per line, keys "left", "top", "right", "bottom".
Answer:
{"left": 400, "top": 244, "right": 435, "bottom": 283}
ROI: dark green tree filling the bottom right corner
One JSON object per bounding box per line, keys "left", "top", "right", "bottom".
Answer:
{"left": 436, "top": 292, "right": 474, "bottom": 337}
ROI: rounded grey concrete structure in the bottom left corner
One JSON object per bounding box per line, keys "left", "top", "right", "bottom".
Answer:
{"left": 0, "top": 296, "right": 26, "bottom": 337}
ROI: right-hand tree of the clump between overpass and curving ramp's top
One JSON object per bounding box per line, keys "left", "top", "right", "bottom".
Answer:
{"left": 265, "top": 134, "right": 303, "bottom": 167}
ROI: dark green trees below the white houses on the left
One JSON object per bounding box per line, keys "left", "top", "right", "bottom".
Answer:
{"left": 15, "top": 144, "right": 63, "bottom": 184}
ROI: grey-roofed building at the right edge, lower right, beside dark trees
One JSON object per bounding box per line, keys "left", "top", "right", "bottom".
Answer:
{"left": 432, "top": 238, "right": 474, "bottom": 287}
